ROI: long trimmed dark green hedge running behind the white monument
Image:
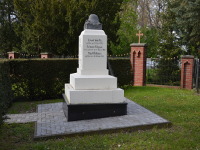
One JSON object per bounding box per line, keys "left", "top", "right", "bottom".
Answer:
{"left": 9, "top": 59, "right": 132, "bottom": 100}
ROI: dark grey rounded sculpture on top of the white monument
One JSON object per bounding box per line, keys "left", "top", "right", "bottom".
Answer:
{"left": 84, "top": 14, "right": 102, "bottom": 30}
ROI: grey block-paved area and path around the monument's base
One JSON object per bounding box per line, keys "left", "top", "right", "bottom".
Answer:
{"left": 6, "top": 99, "right": 171, "bottom": 138}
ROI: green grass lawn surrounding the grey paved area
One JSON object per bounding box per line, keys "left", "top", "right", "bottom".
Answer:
{"left": 0, "top": 87, "right": 200, "bottom": 150}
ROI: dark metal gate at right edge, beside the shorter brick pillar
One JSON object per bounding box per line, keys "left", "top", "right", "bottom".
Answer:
{"left": 193, "top": 59, "right": 200, "bottom": 93}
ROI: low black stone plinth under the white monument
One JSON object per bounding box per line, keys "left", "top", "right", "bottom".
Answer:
{"left": 63, "top": 94, "right": 127, "bottom": 121}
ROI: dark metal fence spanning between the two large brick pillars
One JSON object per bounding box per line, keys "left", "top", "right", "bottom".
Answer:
{"left": 146, "top": 58, "right": 181, "bottom": 86}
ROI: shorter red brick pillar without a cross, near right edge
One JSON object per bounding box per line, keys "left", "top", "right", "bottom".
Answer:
{"left": 181, "top": 55, "right": 194, "bottom": 89}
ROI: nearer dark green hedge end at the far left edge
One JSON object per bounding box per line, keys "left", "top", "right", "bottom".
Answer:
{"left": 0, "top": 61, "right": 13, "bottom": 125}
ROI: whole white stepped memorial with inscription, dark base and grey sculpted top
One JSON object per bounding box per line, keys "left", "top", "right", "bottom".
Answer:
{"left": 64, "top": 14, "right": 126, "bottom": 120}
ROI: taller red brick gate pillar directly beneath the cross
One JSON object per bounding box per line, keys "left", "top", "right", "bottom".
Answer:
{"left": 130, "top": 43, "right": 147, "bottom": 86}
